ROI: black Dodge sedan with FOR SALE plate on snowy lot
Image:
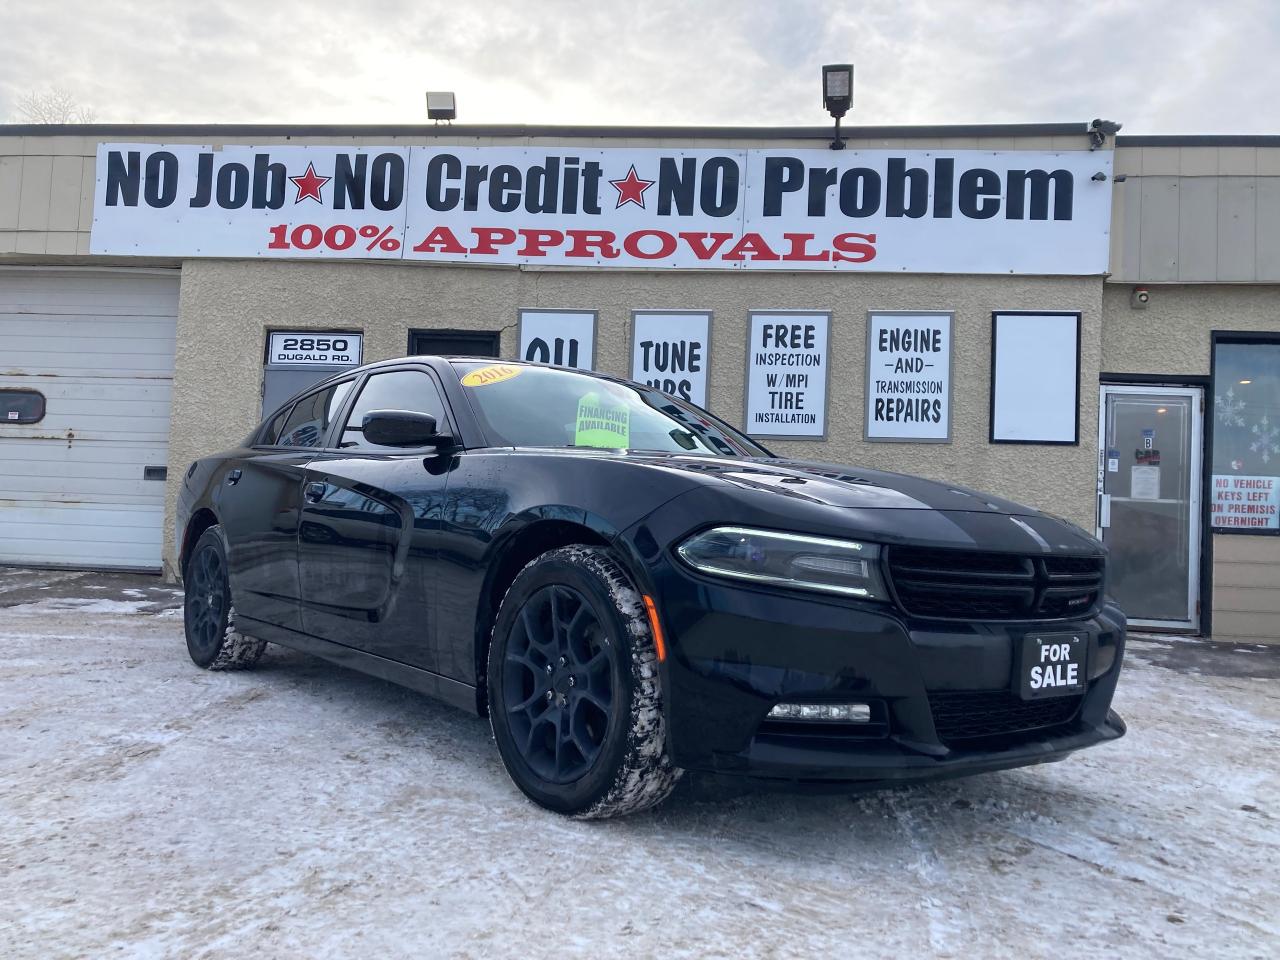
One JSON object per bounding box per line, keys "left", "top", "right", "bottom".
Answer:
{"left": 177, "top": 357, "right": 1125, "bottom": 817}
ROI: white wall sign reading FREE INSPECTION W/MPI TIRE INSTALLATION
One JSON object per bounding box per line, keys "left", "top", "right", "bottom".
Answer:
{"left": 746, "top": 310, "right": 831, "bottom": 440}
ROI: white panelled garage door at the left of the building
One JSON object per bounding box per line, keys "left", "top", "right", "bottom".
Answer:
{"left": 0, "top": 270, "right": 178, "bottom": 570}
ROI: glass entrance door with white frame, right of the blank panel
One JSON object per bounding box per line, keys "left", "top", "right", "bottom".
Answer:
{"left": 1098, "top": 385, "right": 1203, "bottom": 630}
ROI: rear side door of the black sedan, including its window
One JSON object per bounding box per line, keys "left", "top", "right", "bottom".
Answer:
{"left": 215, "top": 380, "right": 355, "bottom": 630}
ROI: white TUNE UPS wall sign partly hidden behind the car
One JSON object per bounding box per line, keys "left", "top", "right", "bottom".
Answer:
{"left": 631, "top": 310, "right": 712, "bottom": 410}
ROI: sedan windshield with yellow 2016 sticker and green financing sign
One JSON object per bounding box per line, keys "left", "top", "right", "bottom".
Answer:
{"left": 453, "top": 361, "right": 769, "bottom": 457}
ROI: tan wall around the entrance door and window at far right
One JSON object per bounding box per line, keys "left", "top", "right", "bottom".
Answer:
{"left": 1102, "top": 283, "right": 1280, "bottom": 643}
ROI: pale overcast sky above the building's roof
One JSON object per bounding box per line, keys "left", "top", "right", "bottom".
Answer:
{"left": 0, "top": 0, "right": 1280, "bottom": 133}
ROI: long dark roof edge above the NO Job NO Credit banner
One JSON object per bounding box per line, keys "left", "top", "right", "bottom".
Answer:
{"left": 0, "top": 123, "right": 1088, "bottom": 141}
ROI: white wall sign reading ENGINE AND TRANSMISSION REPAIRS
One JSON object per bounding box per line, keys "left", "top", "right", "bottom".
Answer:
{"left": 867, "top": 312, "right": 952, "bottom": 442}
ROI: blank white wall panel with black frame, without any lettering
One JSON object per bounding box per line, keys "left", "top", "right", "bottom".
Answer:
{"left": 991, "top": 314, "right": 1080, "bottom": 443}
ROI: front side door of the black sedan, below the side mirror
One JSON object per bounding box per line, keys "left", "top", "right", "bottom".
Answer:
{"left": 298, "top": 366, "right": 454, "bottom": 671}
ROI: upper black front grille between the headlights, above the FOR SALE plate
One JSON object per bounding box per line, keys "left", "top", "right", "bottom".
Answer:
{"left": 888, "top": 547, "right": 1105, "bottom": 621}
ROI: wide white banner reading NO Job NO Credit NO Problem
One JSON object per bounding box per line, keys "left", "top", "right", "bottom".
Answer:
{"left": 90, "top": 143, "right": 1111, "bottom": 275}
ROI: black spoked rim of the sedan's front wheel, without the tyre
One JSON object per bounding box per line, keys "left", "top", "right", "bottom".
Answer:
{"left": 502, "top": 584, "right": 617, "bottom": 783}
